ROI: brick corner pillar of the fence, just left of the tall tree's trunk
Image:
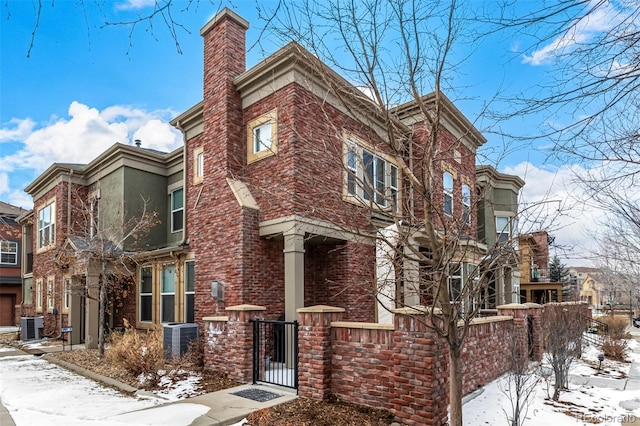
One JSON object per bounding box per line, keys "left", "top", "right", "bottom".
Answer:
{"left": 390, "top": 308, "right": 449, "bottom": 426}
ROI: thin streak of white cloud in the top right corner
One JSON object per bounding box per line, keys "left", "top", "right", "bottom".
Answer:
{"left": 522, "top": 2, "right": 627, "bottom": 66}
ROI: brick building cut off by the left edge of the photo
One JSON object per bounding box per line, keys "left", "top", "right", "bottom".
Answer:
{"left": 0, "top": 201, "right": 25, "bottom": 326}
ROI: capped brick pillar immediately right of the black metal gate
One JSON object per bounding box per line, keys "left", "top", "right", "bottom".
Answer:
{"left": 297, "top": 305, "right": 345, "bottom": 401}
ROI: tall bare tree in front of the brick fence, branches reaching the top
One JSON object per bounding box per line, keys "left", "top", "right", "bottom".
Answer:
{"left": 238, "top": 0, "right": 528, "bottom": 425}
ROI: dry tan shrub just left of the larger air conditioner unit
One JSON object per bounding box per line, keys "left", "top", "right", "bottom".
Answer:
{"left": 106, "top": 327, "right": 164, "bottom": 380}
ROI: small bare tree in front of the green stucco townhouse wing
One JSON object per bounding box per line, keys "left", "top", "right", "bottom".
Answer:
{"left": 55, "top": 193, "right": 159, "bottom": 358}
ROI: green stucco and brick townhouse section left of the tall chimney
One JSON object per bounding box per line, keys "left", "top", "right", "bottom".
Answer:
{"left": 22, "top": 146, "right": 185, "bottom": 347}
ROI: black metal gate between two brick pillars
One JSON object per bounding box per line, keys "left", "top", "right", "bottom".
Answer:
{"left": 253, "top": 320, "right": 298, "bottom": 389}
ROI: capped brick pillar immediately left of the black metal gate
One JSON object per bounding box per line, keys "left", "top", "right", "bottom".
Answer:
{"left": 225, "top": 305, "right": 267, "bottom": 383}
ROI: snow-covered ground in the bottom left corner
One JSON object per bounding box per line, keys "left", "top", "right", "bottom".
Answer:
{"left": 0, "top": 355, "right": 209, "bottom": 426}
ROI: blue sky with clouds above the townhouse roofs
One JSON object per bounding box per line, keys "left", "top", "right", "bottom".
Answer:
{"left": 0, "top": 0, "right": 620, "bottom": 264}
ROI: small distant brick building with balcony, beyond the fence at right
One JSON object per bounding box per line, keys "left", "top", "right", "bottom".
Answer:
{"left": 518, "top": 231, "right": 562, "bottom": 304}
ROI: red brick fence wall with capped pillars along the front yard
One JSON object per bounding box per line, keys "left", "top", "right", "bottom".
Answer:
{"left": 204, "top": 304, "right": 585, "bottom": 425}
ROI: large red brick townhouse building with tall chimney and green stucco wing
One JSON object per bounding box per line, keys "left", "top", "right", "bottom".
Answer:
{"left": 26, "top": 9, "right": 522, "bottom": 342}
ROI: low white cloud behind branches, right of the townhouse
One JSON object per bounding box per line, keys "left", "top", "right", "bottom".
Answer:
{"left": 501, "top": 162, "right": 604, "bottom": 266}
